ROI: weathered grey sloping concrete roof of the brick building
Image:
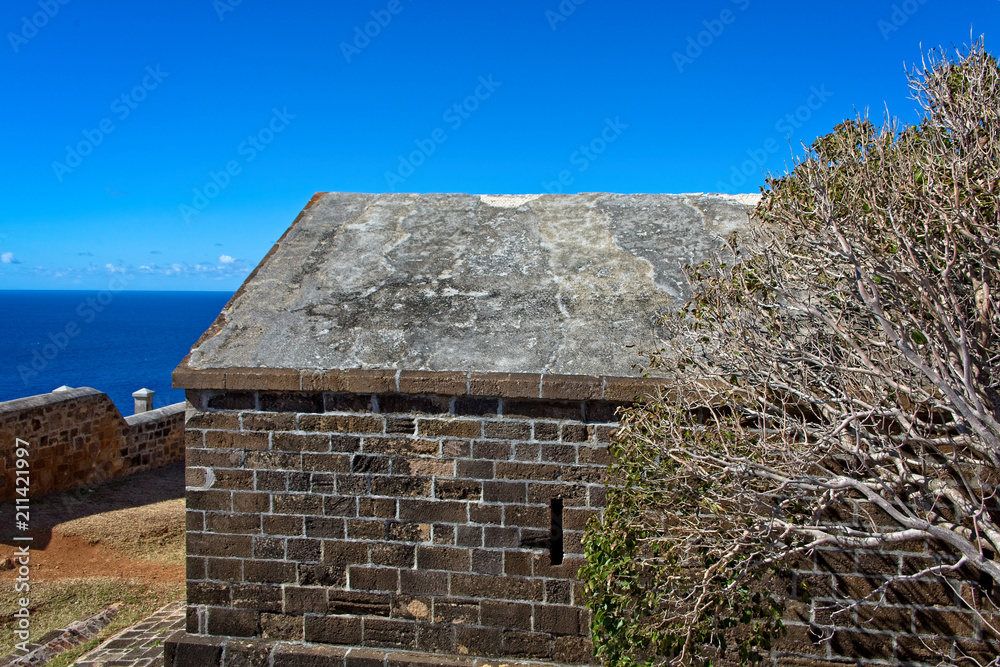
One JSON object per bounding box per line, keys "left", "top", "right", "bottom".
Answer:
{"left": 182, "top": 193, "right": 756, "bottom": 388}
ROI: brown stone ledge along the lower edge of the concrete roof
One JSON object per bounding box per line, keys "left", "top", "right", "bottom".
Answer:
{"left": 173, "top": 366, "right": 669, "bottom": 402}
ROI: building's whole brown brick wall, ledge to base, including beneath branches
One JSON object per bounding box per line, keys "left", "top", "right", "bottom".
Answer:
{"left": 172, "top": 369, "right": 1000, "bottom": 667}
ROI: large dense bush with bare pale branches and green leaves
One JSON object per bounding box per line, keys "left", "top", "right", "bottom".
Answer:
{"left": 584, "top": 42, "right": 1000, "bottom": 666}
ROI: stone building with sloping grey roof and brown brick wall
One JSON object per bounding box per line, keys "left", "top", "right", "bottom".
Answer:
{"left": 166, "top": 193, "right": 752, "bottom": 667}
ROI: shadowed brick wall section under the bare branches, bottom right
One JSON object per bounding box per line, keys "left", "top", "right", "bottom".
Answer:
{"left": 774, "top": 524, "right": 1000, "bottom": 666}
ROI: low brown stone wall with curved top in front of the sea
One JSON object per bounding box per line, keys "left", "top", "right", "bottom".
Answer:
{"left": 0, "top": 387, "right": 184, "bottom": 501}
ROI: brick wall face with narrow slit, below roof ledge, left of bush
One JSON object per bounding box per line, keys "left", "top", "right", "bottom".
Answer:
{"left": 181, "top": 382, "right": 616, "bottom": 664}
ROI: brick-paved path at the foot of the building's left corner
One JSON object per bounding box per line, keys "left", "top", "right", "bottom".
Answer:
{"left": 73, "top": 600, "right": 186, "bottom": 667}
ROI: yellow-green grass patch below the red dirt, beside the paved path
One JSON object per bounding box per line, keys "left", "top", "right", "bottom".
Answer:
{"left": 0, "top": 577, "right": 185, "bottom": 656}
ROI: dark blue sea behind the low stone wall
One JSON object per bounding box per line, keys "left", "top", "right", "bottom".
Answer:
{"left": 0, "top": 290, "right": 232, "bottom": 416}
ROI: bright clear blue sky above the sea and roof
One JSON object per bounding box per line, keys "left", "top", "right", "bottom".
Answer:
{"left": 0, "top": 0, "right": 1000, "bottom": 290}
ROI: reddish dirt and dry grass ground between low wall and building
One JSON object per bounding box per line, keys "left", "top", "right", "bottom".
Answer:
{"left": 0, "top": 464, "right": 185, "bottom": 664}
